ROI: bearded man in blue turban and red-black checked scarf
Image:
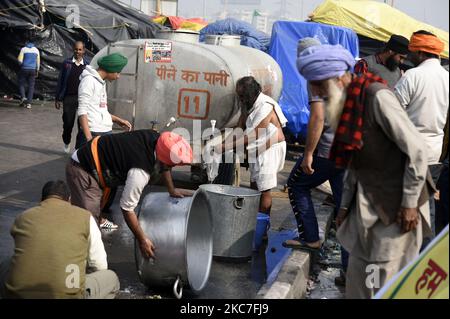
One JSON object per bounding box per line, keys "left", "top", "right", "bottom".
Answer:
{"left": 297, "top": 45, "right": 434, "bottom": 298}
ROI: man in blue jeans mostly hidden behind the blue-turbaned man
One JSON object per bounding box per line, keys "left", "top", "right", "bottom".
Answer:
{"left": 283, "top": 38, "right": 348, "bottom": 285}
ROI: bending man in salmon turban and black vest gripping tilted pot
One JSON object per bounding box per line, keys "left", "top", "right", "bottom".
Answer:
{"left": 66, "top": 130, "right": 192, "bottom": 257}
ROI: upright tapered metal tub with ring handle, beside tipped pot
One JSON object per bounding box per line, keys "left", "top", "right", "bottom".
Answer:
{"left": 200, "top": 184, "right": 261, "bottom": 259}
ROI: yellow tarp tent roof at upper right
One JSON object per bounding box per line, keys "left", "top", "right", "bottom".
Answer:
{"left": 310, "top": 0, "right": 449, "bottom": 59}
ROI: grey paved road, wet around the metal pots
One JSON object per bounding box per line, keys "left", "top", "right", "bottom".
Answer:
{"left": 0, "top": 102, "right": 306, "bottom": 298}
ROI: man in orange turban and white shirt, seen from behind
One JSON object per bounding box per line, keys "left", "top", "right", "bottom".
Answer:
{"left": 395, "top": 30, "right": 449, "bottom": 247}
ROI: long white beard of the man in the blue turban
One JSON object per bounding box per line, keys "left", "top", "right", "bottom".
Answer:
{"left": 325, "top": 79, "right": 347, "bottom": 132}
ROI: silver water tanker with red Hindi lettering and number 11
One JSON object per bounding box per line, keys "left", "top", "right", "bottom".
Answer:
{"left": 91, "top": 31, "right": 282, "bottom": 141}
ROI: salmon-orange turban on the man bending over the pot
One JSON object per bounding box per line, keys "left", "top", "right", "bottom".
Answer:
{"left": 156, "top": 132, "right": 192, "bottom": 166}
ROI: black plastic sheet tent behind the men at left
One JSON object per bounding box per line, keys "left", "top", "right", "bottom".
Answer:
{"left": 0, "top": 0, "right": 164, "bottom": 98}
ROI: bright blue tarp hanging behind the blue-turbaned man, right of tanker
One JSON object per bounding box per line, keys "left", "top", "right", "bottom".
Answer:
{"left": 269, "top": 21, "right": 359, "bottom": 137}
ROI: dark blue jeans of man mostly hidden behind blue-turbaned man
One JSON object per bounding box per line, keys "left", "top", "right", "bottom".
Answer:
{"left": 287, "top": 155, "right": 344, "bottom": 243}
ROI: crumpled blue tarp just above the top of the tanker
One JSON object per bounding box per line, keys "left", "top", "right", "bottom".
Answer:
{"left": 200, "top": 18, "right": 270, "bottom": 52}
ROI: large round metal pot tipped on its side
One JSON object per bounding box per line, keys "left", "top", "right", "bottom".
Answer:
{"left": 135, "top": 190, "right": 213, "bottom": 298}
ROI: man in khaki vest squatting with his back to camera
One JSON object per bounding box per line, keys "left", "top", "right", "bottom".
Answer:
{"left": 0, "top": 181, "right": 120, "bottom": 299}
